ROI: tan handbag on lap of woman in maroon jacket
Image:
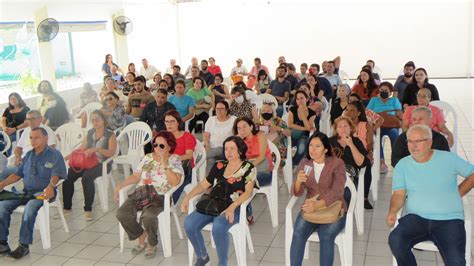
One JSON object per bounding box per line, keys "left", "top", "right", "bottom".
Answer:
{"left": 303, "top": 194, "right": 344, "bottom": 224}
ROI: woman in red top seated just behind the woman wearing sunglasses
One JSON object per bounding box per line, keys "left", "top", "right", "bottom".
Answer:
{"left": 165, "top": 110, "right": 196, "bottom": 203}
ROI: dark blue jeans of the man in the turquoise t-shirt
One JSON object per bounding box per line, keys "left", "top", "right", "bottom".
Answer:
{"left": 388, "top": 214, "right": 471, "bottom": 266}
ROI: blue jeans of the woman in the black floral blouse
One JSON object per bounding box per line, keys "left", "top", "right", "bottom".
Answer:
{"left": 184, "top": 208, "right": 240, "bottom": 265}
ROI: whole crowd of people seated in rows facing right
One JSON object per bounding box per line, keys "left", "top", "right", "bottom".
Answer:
{"left": 0, "top": 54, "right": 474, "bottom": 265}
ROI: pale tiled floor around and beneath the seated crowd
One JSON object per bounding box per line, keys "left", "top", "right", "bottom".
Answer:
{"left": 0, "top": 79, "right": 474, "bottom": 266}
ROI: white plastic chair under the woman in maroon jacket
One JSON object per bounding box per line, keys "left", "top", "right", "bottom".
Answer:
{"left": 285, "top": 178, "right": 358, "bottom": 266}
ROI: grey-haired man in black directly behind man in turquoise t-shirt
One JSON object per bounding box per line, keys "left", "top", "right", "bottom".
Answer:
{"left": 392, "top": 106, "right": 449, "bottom": 168}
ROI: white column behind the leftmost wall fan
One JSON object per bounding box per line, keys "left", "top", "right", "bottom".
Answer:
{"left": 34, "top": 6, "right": 57, "bottom": 89}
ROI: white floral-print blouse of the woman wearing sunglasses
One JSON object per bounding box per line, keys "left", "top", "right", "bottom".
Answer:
{"left": 135, "top": 153, "right": 184, "bottom": 195}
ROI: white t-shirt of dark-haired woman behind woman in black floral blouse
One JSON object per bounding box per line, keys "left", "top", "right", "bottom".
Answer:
{"left": 205, "top": 116, "right": 237, "bottom": 149}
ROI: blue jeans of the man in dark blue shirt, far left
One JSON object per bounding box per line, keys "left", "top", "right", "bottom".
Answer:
{"left": 0, "top": 199, "right": 43, "bottom": 245}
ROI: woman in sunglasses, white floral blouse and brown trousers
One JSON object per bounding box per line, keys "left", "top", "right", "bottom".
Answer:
{"left": 114, "top": 131, "right": 183, "bottom": 259}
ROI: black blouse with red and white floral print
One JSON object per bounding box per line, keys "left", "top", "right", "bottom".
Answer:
{"left": 206, "top": 161, "right": 258, "bottom": 202}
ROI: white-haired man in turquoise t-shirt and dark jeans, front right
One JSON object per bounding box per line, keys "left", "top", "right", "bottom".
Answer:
{"left": 387, "top": 125, "right": 474, "bottom": 265}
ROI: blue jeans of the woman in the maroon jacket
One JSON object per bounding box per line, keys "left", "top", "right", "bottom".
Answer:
{"left": 290, "top": 213, "right": 346, "bottom": 266}
